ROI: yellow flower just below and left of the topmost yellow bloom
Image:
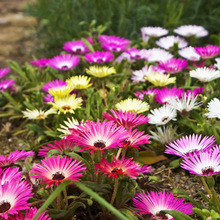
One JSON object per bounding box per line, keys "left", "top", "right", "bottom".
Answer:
{"left": 66, "top": 76, "right": 92, "bottom": 89}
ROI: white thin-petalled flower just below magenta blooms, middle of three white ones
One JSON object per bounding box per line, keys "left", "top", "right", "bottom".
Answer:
{"left": 167, "top": 93, "right": 202, "bottom": 112}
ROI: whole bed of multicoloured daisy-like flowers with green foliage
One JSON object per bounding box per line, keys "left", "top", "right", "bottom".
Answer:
{"left": 0, "top": 21, "right": 220, "bottom": 220}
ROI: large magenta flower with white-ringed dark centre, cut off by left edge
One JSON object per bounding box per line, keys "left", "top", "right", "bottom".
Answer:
{"left": 0, "top": 181, "right": 33, "bottom": 219}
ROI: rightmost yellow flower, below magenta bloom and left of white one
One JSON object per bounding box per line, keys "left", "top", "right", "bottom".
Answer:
{"left": 144, "top": 73, "right": 176, "bottom": 87}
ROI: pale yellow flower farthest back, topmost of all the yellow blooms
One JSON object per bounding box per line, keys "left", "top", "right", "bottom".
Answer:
{"left": 86, "top": 66, "right": 116, "bottom": 78}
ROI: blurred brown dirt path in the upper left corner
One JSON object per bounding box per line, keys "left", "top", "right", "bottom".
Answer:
{"left": 0, "top": 0, "right": 36, "bottom": 68}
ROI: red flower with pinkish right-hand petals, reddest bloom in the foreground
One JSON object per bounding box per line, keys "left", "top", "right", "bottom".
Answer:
{"left": 94, "top": 156, "right": 153, "bottom": 179}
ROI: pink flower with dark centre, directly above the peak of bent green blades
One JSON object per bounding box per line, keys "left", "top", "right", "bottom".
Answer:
{"left": 30, "top": 156, "right": 86, "bottom": 187}
